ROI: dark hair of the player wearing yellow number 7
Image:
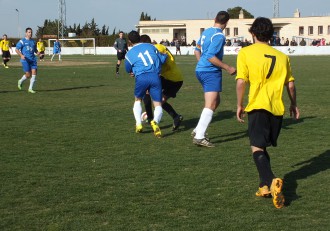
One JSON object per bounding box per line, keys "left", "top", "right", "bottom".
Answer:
{"left": 249, "top": 17, "right": 274, "bottom": 42}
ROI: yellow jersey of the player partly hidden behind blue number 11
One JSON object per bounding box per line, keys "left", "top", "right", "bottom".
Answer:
{"left": 155, "top": 44, "right": 183, "bottom": 82}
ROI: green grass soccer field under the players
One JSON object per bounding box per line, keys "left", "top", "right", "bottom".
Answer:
{"left": 0, "top": 56, "right": 330, "bottom": 231}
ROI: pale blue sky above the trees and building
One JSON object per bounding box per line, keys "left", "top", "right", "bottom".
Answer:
{"left": 0, "top": 0, "right": 330, "bottom": 38}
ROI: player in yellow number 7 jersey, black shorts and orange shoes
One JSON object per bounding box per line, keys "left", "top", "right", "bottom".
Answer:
{"left": 236, "top": 17, "right": 299, "bottom": 208}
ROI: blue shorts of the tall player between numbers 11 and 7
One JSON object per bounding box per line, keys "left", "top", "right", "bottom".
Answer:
{"left": 196, "top": 71, "right": 222, "bottom": 92}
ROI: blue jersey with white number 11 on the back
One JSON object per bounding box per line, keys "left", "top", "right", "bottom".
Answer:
{"left": 125, "top": 43, "right": 167, "bottom": 77}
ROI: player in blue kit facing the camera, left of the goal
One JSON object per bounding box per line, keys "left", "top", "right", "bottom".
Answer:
{"left": 15, "top": 27, "right": 39, "bottom": 94}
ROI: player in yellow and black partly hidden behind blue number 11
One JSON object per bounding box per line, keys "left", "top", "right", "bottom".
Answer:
{"left": 141, "top": 35, "right": 183, "bottom": 131}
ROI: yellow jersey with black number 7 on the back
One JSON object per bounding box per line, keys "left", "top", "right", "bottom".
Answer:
{"left": 236, "top": 43, "right": 294, "bottom": 116}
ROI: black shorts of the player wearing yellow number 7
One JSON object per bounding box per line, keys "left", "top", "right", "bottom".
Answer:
{"left": 248, "top": 110, "right": 283, "bottom": 148}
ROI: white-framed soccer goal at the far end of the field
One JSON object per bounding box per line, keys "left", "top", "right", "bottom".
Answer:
{"left": 48, "top": 38, "right": 96, "bottom": 55}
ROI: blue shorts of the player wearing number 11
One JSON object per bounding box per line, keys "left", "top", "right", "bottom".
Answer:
{"left": 134, "top": 73, "right": 162, "bottom": 102}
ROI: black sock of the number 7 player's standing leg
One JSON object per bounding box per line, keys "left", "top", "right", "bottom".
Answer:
{"left": 253, "top": 151, "right": 274, "bottom": 187}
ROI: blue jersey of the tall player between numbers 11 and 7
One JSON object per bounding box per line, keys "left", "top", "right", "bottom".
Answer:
{"left": 195, "top": 27, "right": 226, "bottom": 72}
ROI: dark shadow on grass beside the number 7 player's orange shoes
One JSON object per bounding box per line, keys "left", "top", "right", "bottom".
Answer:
{"left": 283, "top": 150, "right": 330, "bottom": 205}
